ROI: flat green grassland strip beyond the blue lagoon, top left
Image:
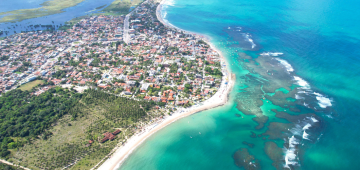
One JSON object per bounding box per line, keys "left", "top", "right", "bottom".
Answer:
{"left": 0, "top": 0, "right": 84, "bottom": 23}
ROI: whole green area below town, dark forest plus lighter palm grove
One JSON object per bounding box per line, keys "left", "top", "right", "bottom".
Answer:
{"left": 0, "top": 87, "right": 155, "bottom": 169}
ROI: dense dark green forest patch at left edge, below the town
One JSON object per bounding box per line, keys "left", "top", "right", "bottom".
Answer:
{"left": 0, "top": 88, "right": 81, "bottom": 157}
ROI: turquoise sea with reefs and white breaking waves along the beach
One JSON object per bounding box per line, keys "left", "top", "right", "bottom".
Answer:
{"left": 125, "top": 0, "right": 360, "bottom": 170}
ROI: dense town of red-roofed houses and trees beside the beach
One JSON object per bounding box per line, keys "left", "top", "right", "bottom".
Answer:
{"left": 0, "top": 1, "right": 223, "bottom": 110}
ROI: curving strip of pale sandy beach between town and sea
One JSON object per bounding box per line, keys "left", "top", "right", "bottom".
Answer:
{"left": 92, "top": 0, "right": 236, "bottom": 170}
